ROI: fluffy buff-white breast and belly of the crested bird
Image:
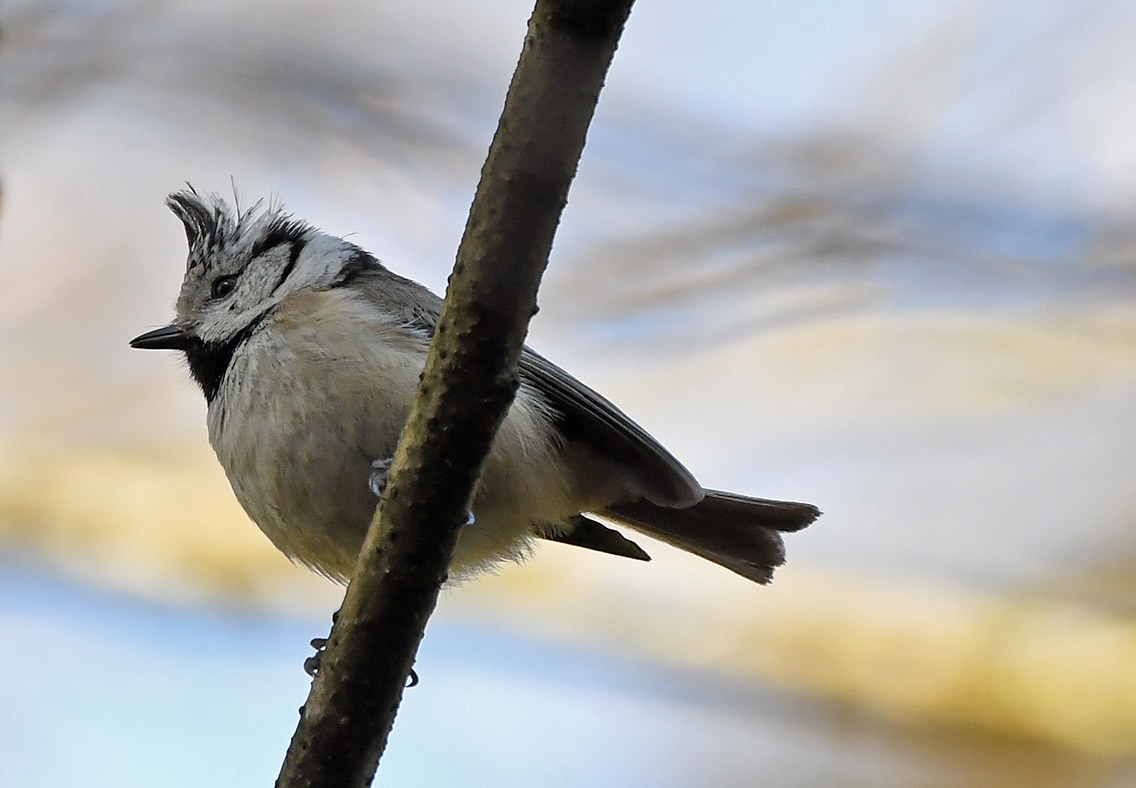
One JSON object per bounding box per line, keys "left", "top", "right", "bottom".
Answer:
{"left": 202, "top": 288, "right": 579, "bottom": 579}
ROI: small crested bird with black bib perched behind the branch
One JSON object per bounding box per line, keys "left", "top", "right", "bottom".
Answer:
{"left": 130, "top": 189, "right": 820, "bottom": 584}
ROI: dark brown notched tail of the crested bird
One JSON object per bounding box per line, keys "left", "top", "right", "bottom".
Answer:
{"left": 596, "top": 489, "right": 820, "bottom": 584}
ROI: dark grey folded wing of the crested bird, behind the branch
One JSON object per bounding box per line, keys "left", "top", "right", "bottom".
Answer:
{"left": 344, "top": 262, "right": 702, "bottom": 508}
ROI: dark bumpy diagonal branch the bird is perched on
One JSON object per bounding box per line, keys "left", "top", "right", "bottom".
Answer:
{"left": 276, "top": 0, "right": 633, "bottom": 788}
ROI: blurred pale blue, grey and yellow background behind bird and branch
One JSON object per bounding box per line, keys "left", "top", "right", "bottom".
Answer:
{"left": 0, "top": 0, "right": 1136, "bottom": 788}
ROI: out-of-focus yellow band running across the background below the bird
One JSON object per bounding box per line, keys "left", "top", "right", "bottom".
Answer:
{"left": 0, "top": 447, "right": 1136, "bottom": 757}
